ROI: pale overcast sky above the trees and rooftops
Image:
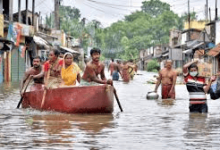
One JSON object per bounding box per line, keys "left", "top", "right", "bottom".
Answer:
{"left": 13, "top": 0, "right": 217, "bottom": 27}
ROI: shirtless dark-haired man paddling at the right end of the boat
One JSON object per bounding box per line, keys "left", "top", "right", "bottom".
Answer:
{"left": 80, "top": 48, "right": 112, "bottom": 85}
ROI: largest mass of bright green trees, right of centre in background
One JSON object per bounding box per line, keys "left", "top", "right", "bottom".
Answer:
{"left": 92, "top": 0, "right": 193, "bottom": 60}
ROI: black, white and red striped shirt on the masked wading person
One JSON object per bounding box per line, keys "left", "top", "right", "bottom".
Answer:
{"left": 184, "top": 74, "right": 206, "bottom": 104}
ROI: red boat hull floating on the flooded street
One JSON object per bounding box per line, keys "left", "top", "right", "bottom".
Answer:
{"left": 22, "top": 85, "right": 114, "bottom": 113}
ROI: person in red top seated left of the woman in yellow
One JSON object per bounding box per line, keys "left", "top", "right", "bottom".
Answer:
{"left": 33, "top": 49, "right": 63, "bottom": 88}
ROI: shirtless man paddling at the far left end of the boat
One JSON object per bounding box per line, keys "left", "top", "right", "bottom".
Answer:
{"left": 20, "top": 56, "right": 44, "bottom": 95}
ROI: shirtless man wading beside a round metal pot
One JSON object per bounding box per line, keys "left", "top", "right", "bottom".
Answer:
{"left": 155, "top": 60, "right": 177, "bottom": 99}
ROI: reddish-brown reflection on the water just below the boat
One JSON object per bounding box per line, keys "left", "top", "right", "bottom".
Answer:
{"left": 26, "top": 114, "right": 114, "bottom": 148}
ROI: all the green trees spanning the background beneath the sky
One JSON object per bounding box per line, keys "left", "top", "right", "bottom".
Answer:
{"left": 46, "top": 0, "right": 196, "bottom": 60}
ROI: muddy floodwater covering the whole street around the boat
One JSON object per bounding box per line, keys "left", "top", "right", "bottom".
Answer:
{"left": 0, "top": 71, "right": 220, "bottom": 150}
